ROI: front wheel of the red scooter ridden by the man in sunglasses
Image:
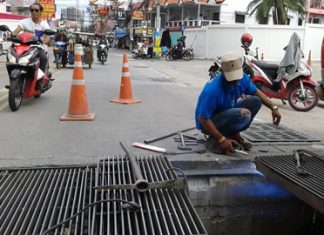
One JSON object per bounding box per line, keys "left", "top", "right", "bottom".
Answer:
{"left": 8, "top": 78, "right": 23, "bottom": 112}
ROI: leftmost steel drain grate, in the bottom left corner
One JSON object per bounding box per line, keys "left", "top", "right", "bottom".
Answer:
{"left": 0, "top": 167, "right": 95, "bottom": 235}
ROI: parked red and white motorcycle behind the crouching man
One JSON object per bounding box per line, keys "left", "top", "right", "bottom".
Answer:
{"left": 241, "top": 33, "right": 318, "bottom": 112}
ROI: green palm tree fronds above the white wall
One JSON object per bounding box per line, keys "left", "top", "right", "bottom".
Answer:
{"left": 247, "top": 0, "right": 307, "bottom": 25}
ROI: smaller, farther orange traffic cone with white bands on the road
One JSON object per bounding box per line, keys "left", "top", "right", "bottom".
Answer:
{"left": 110, "top": 54, "right": 141, "bottom": 104}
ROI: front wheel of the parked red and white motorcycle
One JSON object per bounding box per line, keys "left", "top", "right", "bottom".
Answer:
{"left": 288, "top": 84, "right": 318, "bottom": 112}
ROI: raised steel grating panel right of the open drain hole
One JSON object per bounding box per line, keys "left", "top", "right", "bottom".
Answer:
{"left": 255, "top": 153, "right": 324, "bottom": 214}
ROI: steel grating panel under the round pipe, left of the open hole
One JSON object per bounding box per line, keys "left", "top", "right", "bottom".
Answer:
{"left": 95, "top": 156, "right": 207, "bottom": 235}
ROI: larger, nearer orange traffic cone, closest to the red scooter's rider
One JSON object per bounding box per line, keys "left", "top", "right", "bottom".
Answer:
{"left": 60, "top": 44, "right": 95, "bottom": 121}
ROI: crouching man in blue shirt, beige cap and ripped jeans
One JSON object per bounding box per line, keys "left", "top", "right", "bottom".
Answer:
{"left": 195, "top": 53, "right": 281, "bottom": 153}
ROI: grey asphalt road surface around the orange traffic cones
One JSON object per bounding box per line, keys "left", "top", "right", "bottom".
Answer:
{"left": 0, "top": 49, "right": 324, "bottom": 168}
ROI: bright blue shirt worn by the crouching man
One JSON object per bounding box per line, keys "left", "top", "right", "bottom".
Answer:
{"left": 195, "top": 74, "right": 257, "bottom": 130}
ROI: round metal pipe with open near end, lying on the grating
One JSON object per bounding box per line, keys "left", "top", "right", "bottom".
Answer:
{"left": 120, "top": 142, "right": 149, "bottom": 192}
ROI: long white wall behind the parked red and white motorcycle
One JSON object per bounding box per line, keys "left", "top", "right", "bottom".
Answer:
{"left": 185, "top": 24, "right": 324, "bottom": 61}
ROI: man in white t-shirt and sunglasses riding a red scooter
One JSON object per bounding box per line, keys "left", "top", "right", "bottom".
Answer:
{"left": 12, "top": 3, "right": 51, "bottom": 89}
